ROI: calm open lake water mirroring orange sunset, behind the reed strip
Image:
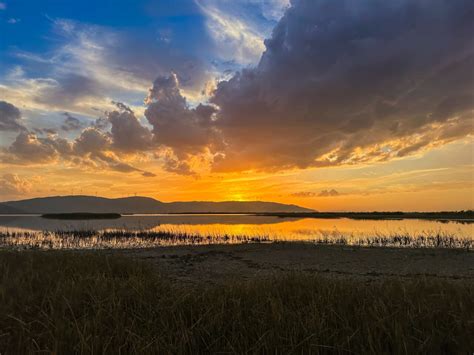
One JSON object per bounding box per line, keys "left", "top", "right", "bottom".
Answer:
{"left": 0, "top": 215, "right": 474, "bottom": 248}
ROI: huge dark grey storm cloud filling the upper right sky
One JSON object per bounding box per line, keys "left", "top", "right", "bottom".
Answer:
{"left": 156, "top": 0, "right": 474, "bottom": 171}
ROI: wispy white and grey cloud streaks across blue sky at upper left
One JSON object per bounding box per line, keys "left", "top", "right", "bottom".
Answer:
{"left": 0, "top": 18, "right": 211, "bottom": 120}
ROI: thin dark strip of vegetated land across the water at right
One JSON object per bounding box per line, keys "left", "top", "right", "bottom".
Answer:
{"left": 257, "top": 210, "right": 474, "bottom": 222}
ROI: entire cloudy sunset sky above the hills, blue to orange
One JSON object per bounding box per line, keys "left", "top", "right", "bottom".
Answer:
{"left": 0, "top": 0, "right": 474, "bottom": 211}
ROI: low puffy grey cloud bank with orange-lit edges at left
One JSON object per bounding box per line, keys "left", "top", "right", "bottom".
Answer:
{"left": 0, "top": 103, "right": 155, "bottom": 177}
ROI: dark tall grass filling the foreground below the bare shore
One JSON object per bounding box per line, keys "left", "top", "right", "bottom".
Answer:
{"left": 0, "top": 251, "right": 474, "bottom": 354}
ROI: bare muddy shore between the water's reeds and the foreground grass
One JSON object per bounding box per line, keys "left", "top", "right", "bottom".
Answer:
{"left": 113, "top": 243, "right": 474, "bottom": 283}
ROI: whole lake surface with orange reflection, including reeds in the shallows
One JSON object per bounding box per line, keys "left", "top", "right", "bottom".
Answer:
{"left": 0, "top": 215, "right": 474, "bottom": 249}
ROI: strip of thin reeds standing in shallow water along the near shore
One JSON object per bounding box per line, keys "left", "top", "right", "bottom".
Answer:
{"left": 0, "top": 229, "right": 474, "bottom": 250}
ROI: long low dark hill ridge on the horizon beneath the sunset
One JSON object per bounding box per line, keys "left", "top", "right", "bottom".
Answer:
{"left": 0, "top": 195, "right": 313, "bottom": 214}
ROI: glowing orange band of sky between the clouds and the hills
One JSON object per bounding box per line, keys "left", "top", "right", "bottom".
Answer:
{"left": 0, "top": 142, "right": 474, "bottom": 211}
